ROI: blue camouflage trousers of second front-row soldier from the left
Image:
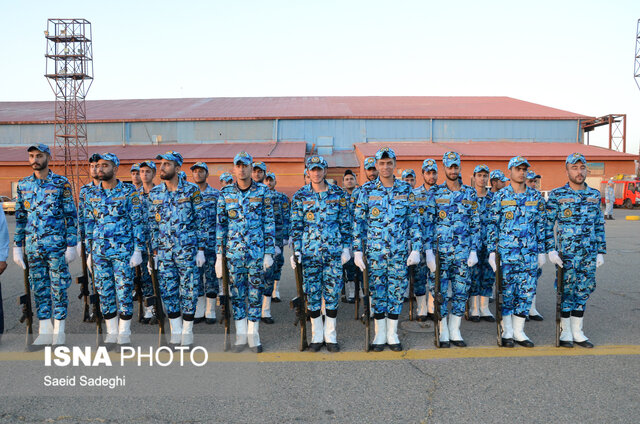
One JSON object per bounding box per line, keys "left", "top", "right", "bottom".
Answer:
{"left": 93, "top": 255, "right": 135, "bottom": 319}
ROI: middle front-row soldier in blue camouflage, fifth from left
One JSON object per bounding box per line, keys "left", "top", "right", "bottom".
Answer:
{"left": 291, "top": 156, "right": 351, "bottom": 352}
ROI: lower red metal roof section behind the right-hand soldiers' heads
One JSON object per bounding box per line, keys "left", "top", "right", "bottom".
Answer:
{"left": 354, "top": 141, "right": 637, "bottom": 161}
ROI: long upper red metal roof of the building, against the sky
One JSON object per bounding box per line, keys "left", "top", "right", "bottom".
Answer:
{"left": 0, "top": 96, "right": 591, "bottom": 124}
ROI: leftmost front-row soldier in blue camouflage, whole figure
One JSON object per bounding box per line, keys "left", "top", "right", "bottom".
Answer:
{"left": 13, "top": 144, "right": 78, "bottom": 346}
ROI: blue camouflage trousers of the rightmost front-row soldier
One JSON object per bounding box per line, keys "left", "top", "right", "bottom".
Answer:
{"left": 556, "top": 253, "right": 596, "bottom": 312}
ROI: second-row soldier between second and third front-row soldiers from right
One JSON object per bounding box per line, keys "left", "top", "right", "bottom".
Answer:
{"left": 469, "top": 165, "right": 496, "bottom": 322}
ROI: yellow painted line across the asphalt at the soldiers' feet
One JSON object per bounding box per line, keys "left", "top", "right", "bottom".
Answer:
{"left": 0, "top": 345, "right": 640, "bottom": 364}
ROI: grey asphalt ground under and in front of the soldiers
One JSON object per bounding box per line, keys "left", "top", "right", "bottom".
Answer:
{"left": 0, "top": 209, "right": 640, "bottom": 423}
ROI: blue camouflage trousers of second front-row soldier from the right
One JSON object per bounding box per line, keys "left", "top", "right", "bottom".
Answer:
{"left": 501, "top": 260, "right": 538, "bottom": 317}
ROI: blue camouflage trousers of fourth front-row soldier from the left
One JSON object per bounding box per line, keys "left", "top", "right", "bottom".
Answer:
{"left": 227, "top": 256, "right": 264, "bottom": 322}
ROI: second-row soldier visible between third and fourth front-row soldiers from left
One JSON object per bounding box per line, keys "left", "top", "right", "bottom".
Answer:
{"left": 190, "top": 162, "right": 220, "bottom": 324}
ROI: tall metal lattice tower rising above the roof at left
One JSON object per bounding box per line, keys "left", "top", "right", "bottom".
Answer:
{"left": 44, "top": 19, "right": 93, "bottom": 198}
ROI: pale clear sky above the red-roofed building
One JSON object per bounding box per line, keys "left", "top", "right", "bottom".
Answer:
{"left": 0, "top": 0, "right": 640, "bottom": 154}
